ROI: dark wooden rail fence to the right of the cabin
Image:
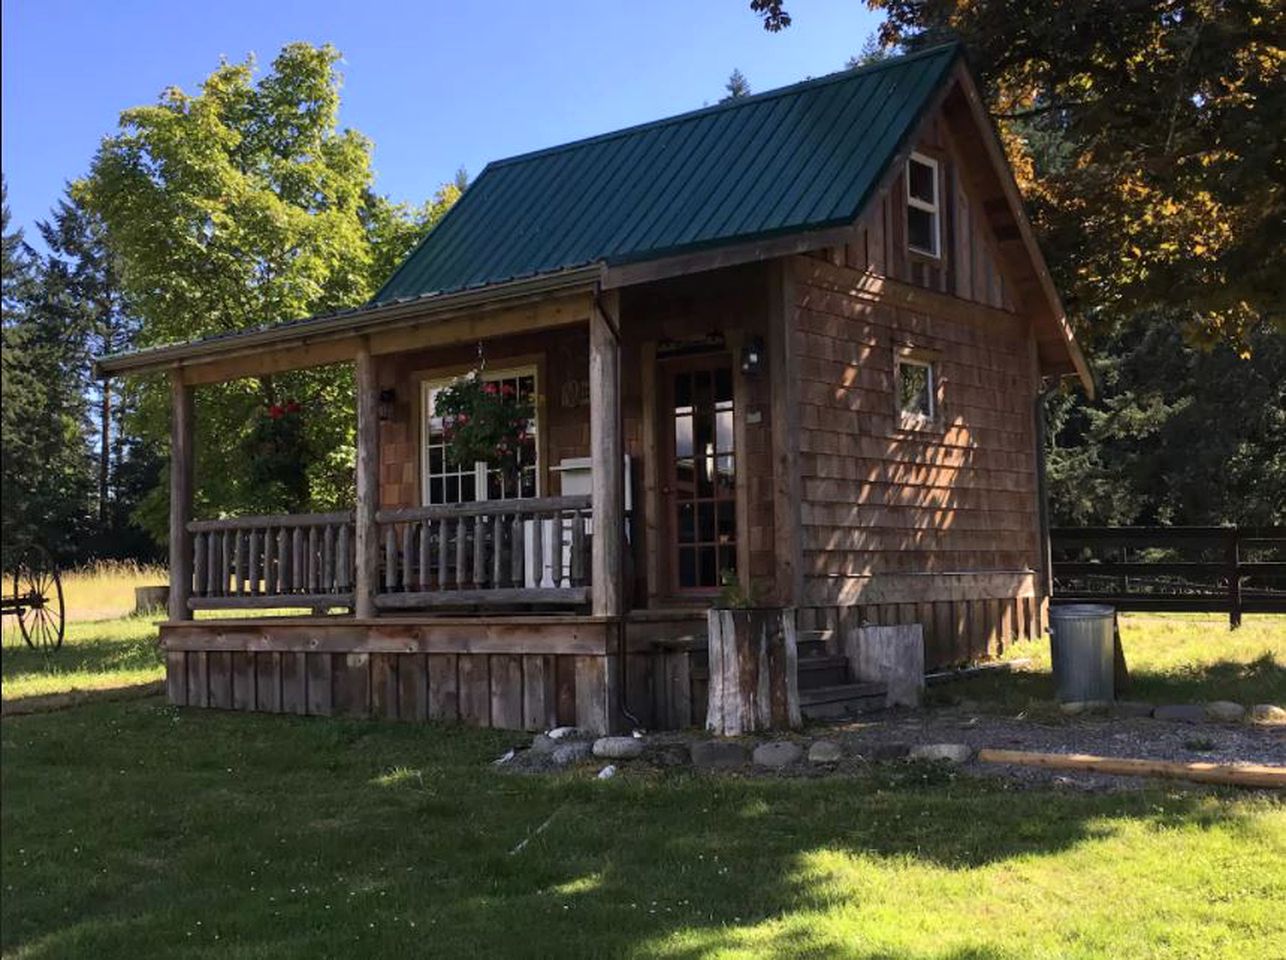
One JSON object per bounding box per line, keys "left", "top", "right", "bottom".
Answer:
{"left": 1051, "top": 527, "right": 1286, "bottom": 627}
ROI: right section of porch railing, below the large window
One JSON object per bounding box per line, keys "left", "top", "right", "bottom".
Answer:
{"left": 376, "top": 496, "right": 592, "bottom": 609}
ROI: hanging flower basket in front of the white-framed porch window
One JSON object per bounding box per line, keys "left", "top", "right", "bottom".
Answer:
{"left": 433, "top": 370, "right": 534, "bottom": 481}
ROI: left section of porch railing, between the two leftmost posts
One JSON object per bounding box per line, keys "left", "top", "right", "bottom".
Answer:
{"left": 188, "top": 513, "right": 355, "bottom": 609}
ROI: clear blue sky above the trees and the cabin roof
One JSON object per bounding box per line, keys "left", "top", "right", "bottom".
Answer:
{"left": 0, "top": 0, "right": 878, "bottom": 248}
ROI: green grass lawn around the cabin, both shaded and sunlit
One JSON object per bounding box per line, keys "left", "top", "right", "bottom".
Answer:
{"left": 0, "top": 618, "right": 1286, "bottom": 960}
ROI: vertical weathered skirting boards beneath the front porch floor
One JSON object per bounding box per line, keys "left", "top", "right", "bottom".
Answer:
{"left": 161, "top": 617, "right": 703, "bottom": 733}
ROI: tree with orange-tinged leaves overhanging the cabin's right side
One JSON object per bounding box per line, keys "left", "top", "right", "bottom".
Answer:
{"left": 868, "top": 0, "right": 1286, "bottom": 351}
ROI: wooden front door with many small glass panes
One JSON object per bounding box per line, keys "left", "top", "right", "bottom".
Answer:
{"left": 658, "top": 355, "right": 737, "bottom": 595}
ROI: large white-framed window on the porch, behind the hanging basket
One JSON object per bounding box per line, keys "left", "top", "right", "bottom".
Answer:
{"left": 419, "top": 366, "right": 540, "bottom": 506}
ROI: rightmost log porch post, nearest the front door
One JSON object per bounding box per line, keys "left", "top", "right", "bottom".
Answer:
{"left": 589, "top": 290, "right": 625, "bottom": 617}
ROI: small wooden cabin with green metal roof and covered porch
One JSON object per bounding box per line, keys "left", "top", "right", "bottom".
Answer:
{"left": 100, "top": 46, "right": 1091, "bottom": 730}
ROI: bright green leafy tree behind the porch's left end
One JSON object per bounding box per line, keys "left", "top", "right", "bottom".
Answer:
{"left": 73, "top": 44, "right": 455, "bottom": 532}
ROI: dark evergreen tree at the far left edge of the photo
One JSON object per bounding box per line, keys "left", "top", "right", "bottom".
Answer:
{"left": 0, "top": 178, "right": 93, "bottom": 564}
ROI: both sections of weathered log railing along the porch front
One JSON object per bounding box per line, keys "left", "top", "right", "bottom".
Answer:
{"left": 188, "top": 496, "right": 592, "bottom": 610}
